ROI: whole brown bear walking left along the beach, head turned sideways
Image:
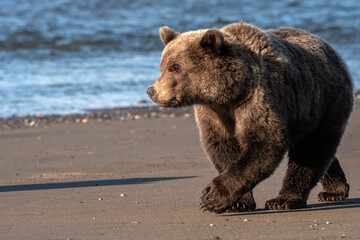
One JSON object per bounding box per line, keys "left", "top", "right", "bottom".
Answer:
{"left": 147, "top": 22, "right": 354, "bottom": 213}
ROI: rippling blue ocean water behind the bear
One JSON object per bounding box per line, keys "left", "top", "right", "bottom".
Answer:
{"left": 0, "top": 0, "right": 360, "bottom": 117}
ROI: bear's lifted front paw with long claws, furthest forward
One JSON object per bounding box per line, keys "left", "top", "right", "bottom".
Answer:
{"left": 200, "top": 178, "right": 233, "bottom": 214}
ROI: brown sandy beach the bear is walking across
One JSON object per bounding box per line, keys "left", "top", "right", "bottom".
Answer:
{"left": 0, "top": 100, "right": 360, "bottom": 240}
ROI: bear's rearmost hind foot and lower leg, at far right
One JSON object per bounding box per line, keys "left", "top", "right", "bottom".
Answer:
{"left": 318, "top": 157, "right": 350, "bottom": 202}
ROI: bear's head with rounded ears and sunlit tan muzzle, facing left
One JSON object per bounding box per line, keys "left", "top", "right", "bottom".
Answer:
{"left": 146, "top": 27, "right": 256, "bottom": 107}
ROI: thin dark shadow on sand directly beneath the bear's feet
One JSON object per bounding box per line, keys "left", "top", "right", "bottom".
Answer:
{"left": 222, "top": 198, "right": 360, "bottom": 217}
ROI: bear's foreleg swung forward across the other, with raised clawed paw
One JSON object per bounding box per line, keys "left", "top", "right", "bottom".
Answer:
{"left": 200, "top": 140, "right": 286, "bottom": 213}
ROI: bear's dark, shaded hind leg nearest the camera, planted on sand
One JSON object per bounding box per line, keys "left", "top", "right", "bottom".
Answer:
{"left": 265, "top": 124, "right": 343, "bottom": 210}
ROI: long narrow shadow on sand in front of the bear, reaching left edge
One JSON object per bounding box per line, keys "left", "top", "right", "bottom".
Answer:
{"left": 0, "top": 176, "right": 197, "bottom": 192}
